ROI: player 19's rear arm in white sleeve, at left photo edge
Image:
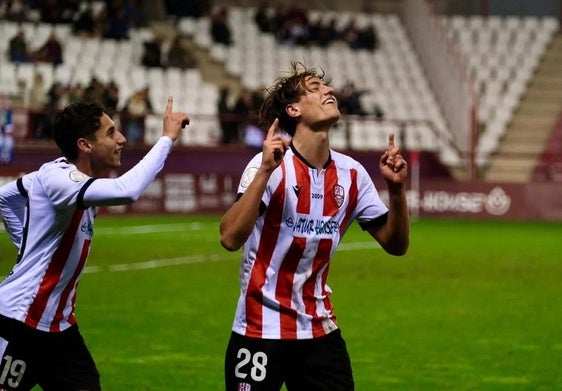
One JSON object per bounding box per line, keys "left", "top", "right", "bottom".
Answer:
{"left": 0, "top": 172, "right": 35, "bottom": 248}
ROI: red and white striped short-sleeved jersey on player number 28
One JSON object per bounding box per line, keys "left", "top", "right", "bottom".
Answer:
{"left": 233, "top": 145, "right": 388, "bottom": 339}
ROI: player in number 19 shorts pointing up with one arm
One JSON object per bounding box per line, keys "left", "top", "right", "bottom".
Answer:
{"left": 0, "top": 97, "right": 189, "bottom": 391}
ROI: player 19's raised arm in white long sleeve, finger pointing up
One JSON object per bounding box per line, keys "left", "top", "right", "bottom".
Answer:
{"left": 82, "top": 97, "right": 189, "bottom": 207}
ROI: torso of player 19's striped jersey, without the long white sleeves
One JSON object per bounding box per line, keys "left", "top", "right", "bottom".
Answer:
{"left": 0, "top": 158, "right": 97, "bottom": 331}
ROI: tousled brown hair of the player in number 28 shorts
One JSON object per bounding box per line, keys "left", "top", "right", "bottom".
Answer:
{"left": 259, "top": 62, "right": 330, "bottom": 136}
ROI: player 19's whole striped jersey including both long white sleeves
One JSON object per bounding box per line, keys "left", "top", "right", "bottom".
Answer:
{"left": 0, "top": 136, "right": 173, "bottom": 332}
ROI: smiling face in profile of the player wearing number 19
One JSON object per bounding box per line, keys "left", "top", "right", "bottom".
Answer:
{"left": 90, "top": 114, "right": 127, "bottom": 172}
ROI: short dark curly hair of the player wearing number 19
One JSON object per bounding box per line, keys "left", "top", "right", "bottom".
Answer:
{"left": 52, "top": 101, "right": 105, "bottom": 161}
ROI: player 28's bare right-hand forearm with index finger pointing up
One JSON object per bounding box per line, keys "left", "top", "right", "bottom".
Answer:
{"left": 369, "top": 134, "right": 410, "bottom": 255}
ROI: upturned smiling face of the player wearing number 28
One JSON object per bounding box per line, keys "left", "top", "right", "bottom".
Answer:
{"left": 296, "top": 77, "right": 340, "bottom": 127}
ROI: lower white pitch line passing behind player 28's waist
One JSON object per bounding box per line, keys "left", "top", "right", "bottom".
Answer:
{"left": 84, "top": 241, "right": 381, "bottom": 274}
